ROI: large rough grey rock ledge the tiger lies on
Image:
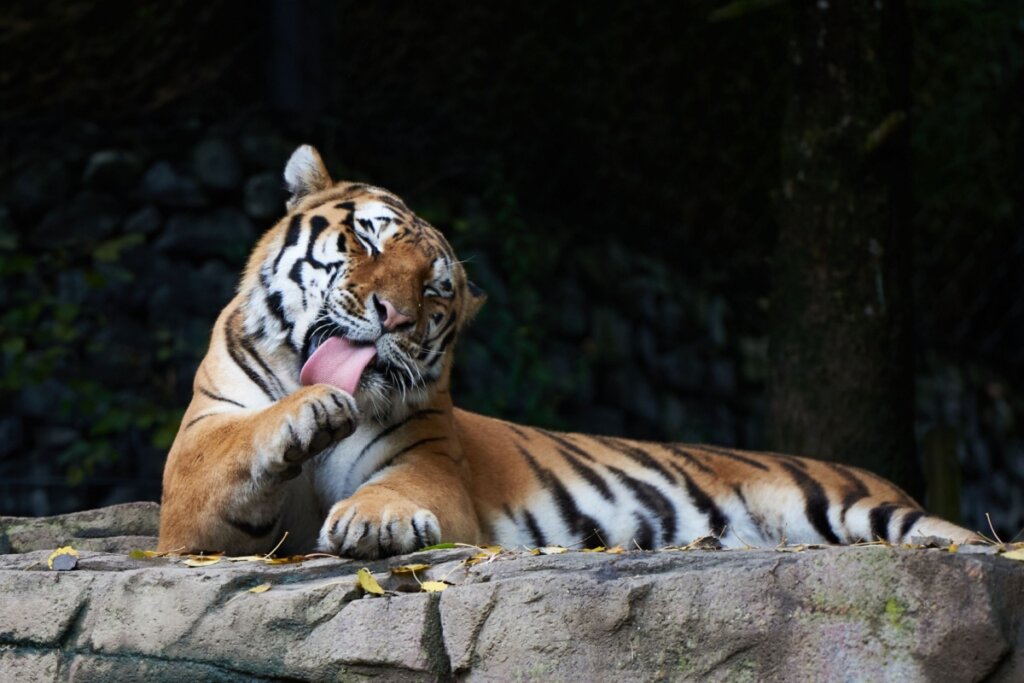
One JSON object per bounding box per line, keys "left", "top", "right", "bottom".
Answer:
{"left": 0, "top": 510, "right": 1024, "bottom": 681}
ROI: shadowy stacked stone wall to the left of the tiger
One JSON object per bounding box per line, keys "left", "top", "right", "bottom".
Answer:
{"left": 0, "top": 125, "right": 288, "bottom": 514}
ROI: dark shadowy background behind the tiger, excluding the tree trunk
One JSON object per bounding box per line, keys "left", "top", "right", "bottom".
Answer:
{"left": 0, "top": 0, "right": 1024, "bottom": 537}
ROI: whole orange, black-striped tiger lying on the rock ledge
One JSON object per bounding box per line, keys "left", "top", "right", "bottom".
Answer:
{"left": 159, "top": 145, "right": 980, "bottom": 559}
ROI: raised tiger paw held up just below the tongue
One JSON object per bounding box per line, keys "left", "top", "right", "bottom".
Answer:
{"left": 259, "top": 384, "right": 358, "bottom": 479}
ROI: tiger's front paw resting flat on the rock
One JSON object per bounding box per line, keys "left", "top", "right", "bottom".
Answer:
{"left": 319, "top": 494, "right": 441, "bottom": 559}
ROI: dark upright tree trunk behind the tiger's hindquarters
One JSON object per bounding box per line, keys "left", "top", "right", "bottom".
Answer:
{"left": 768, "top": 0, "right": 922, "bottom": 494}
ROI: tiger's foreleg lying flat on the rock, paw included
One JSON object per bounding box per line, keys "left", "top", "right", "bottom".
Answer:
{"left": 319, "top": 452, "right": 480, "bottom": 559}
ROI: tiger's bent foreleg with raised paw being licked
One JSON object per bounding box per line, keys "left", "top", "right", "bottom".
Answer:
{"left": 159, "top": 384, "right": 357, "bottom": 554}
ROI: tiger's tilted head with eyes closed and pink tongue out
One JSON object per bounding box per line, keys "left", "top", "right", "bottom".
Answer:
{"left": 241, "top": 145, "right": 485, "bottom": 419}
